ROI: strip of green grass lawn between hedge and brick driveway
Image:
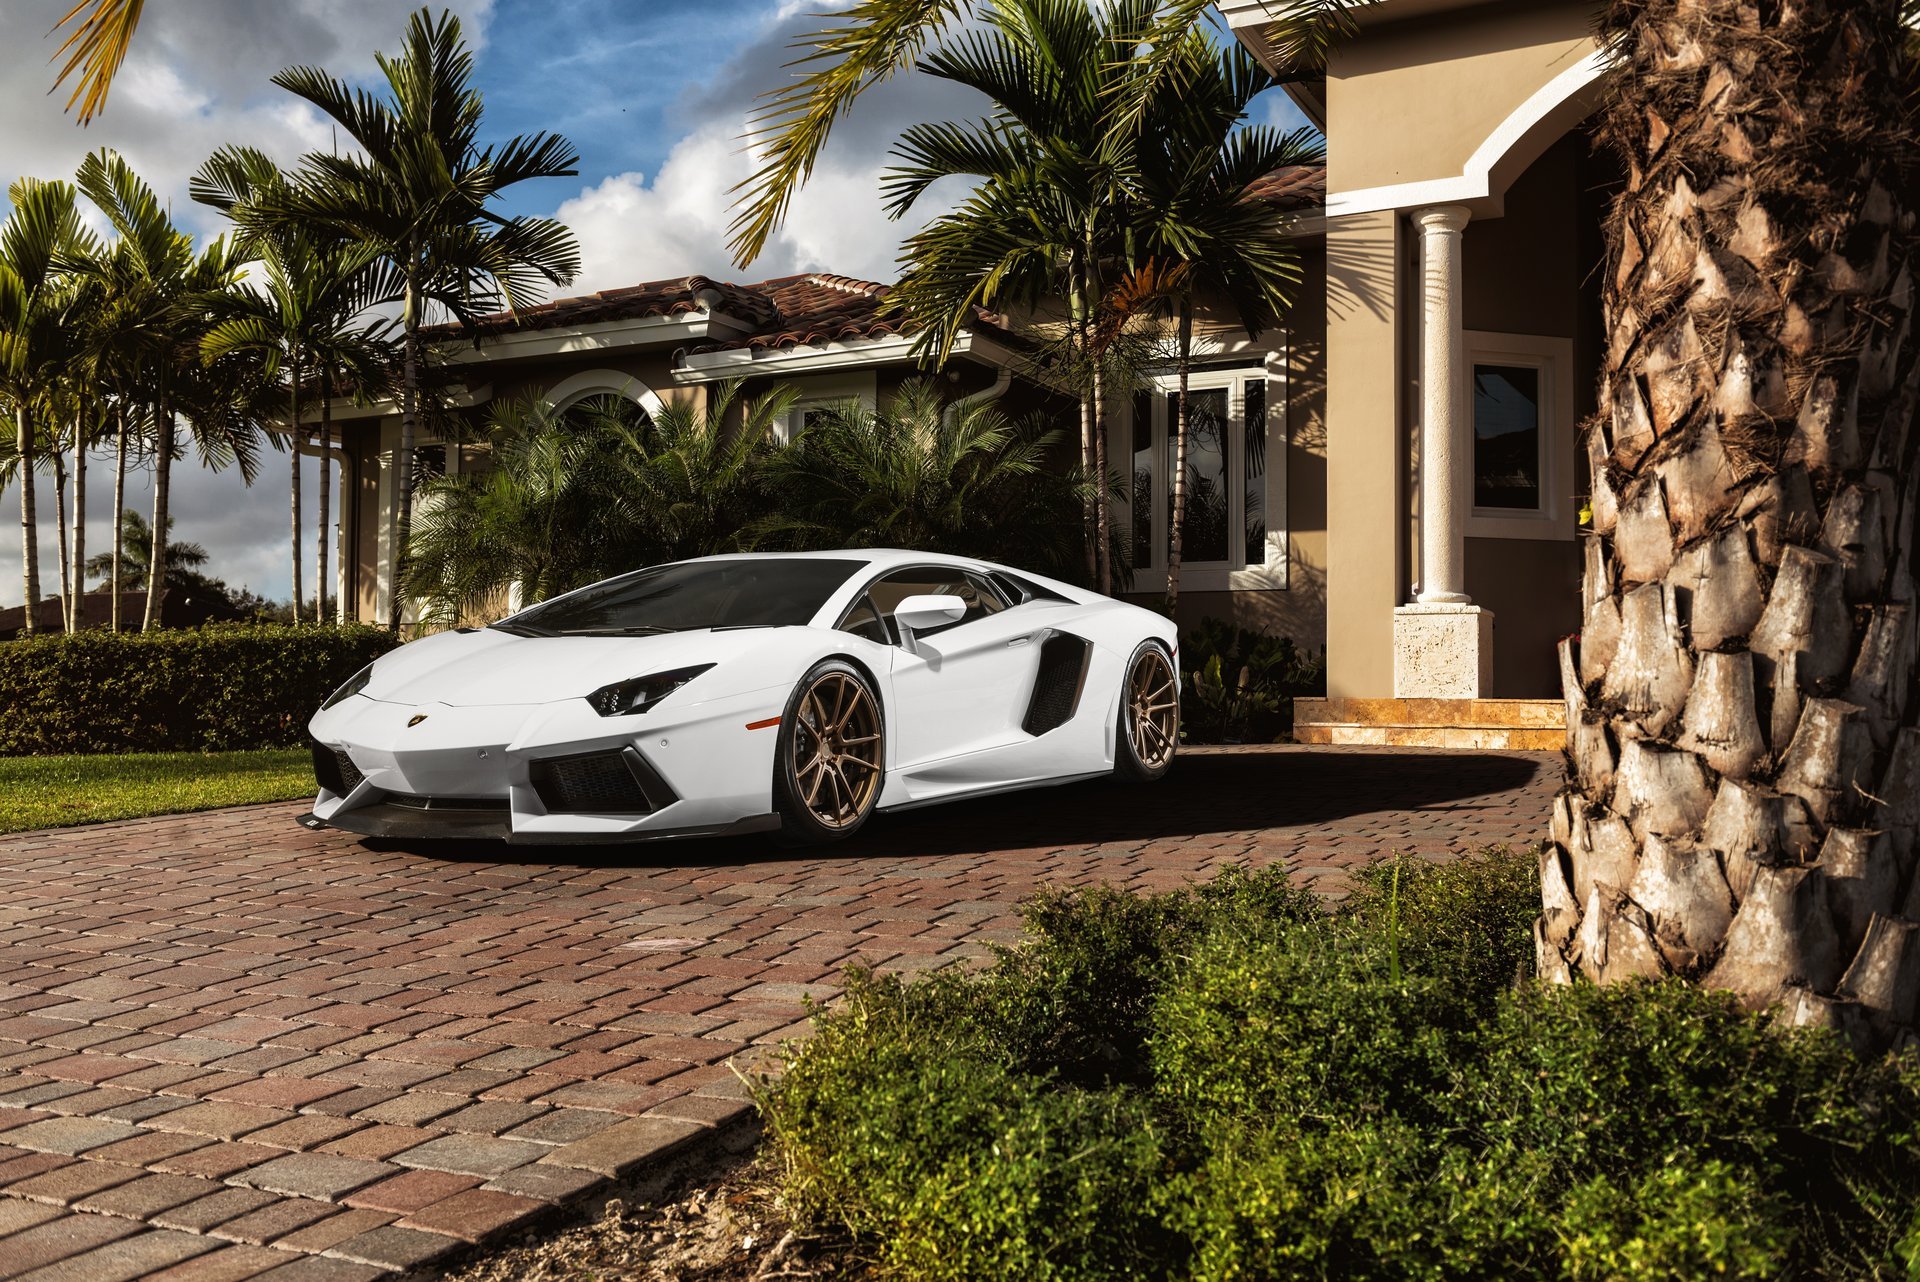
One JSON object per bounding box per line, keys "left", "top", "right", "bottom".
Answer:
{"left": 0, "top": 748, "right": 315, "bottom": 833}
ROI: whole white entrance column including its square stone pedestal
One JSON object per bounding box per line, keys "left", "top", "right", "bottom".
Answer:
{"left": 1394, "top": 205, "right": 1494, "bottom": 699}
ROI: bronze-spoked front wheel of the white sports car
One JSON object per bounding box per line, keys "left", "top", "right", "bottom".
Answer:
{"left": 774, "top": 658, "right": 887, "bottom": 844}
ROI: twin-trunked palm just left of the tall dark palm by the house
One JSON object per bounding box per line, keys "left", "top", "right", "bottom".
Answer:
{"left": 192, "top": 148, "right": 386, "bottom": 622}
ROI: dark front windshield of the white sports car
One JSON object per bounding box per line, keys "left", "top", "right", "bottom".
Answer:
{"left": 493, "top": 557, "right": 866, "bottom": 637}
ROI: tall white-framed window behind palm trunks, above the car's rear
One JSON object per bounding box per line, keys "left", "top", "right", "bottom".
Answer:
{"left": 1108, "top": 353, "right": 1286, "bottom": 591}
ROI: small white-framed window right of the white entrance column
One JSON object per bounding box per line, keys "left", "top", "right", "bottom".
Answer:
{"left": 1453, "top": 330, "right": 1574, "bottom": 539}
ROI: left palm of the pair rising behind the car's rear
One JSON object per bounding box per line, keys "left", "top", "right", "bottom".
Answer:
{"left": 883, "top": 0, "right": 1156, "bottom": 591}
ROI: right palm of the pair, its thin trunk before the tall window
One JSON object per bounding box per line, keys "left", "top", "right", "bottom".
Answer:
{"left": 1133, "top": 29, "right": 1325, "bottom": 614}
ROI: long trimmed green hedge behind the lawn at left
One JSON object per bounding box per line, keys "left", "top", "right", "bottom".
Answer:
{"left": 0, "top": 624, "right": 396, "bottom": 756}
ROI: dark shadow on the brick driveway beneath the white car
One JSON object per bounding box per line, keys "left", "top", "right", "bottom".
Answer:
{"left": 365, "top": 748, "right": 1553, "bottom": 867}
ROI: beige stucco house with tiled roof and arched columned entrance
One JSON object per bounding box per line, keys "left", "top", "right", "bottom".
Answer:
{"left": 322, "top": 0, "right": 1597, "bottom": 747}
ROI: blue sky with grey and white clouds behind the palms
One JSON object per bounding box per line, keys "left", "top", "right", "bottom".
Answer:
{"left": 0, "top": 0, "right": 1304, "bottom": 606}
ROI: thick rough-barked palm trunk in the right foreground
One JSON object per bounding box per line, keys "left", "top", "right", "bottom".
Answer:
{"left": 1536, "top": 0, "right": 1920, "bottom": 1048}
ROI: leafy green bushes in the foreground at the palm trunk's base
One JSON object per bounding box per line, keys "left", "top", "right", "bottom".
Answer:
{"left": 760, "top": 850, "right": 1920, "bottom": 1280}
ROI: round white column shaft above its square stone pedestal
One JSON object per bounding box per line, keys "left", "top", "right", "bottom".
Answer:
{"left": 1413, "top": 205, "right": 1473, "bottom": 605}
